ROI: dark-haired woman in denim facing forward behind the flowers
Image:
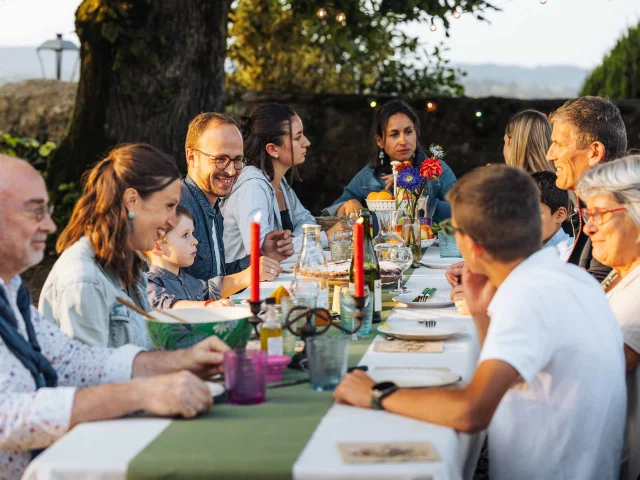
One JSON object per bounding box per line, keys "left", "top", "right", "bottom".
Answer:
{"left": 322, "top": 100, "right": 456, "bottom": 222}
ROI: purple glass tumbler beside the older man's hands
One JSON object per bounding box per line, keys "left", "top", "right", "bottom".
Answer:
{"left": 223, "top": 349, "right": 267, "bottom": 405}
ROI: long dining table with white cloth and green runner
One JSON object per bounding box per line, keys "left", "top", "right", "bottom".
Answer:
{"left": 23, "top": 248, "right": 484, "bottom": 480}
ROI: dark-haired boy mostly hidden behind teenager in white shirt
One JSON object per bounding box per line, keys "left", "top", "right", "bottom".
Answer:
{"left": 531, "top": 172, "right": 573, "bottom": 262}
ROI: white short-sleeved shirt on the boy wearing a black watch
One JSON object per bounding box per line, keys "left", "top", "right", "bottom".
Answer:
{"left": 479, "top": 248, "right": 626, "bottom": 480}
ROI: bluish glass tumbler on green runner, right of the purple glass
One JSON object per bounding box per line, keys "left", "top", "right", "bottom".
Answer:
{"left": 307, "top": 335, "right": 349, "bottom": 392}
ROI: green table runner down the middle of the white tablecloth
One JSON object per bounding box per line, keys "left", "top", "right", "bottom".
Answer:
{"left": 127, "top": 270, "right": 413, "bottom": 480}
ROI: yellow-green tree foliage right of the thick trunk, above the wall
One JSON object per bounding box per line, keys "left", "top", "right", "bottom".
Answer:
{"left": 227, "top": 0, "right": 493, "bottom": 95}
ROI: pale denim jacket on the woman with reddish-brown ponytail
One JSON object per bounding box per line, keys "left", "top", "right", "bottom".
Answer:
{"left": 38, "top": 237, "right": 151, "bottom": 348}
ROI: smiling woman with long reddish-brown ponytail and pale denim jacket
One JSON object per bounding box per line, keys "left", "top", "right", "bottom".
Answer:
{"left": 39, "top": 144, "right": 180, "bottom": 348}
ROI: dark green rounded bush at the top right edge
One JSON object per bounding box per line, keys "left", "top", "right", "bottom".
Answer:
{"left": 580, "top": 23, "right": 640, "bottom": 98}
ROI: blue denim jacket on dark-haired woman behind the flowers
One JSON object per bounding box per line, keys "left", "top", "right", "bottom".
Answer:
{"left": 322, "top": 149, "right": 456, "bottom": 222}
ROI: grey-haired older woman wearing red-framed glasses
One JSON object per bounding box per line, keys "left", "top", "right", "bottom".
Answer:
{"left": 578, "top": 155, "right": 640, "bottom": 480}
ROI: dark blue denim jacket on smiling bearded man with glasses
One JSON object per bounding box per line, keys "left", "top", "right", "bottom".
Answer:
{"left": 180, "top": 175, "right": 249, "bottom": 282}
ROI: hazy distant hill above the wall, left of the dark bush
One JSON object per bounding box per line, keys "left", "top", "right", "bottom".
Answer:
{"left": 455, "top": 64, "right": 589, "bottom": 98}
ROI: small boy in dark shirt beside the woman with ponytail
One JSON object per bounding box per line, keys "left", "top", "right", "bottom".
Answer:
{"left": 145, "top": 205, "right": 233, "bottom": 309}
